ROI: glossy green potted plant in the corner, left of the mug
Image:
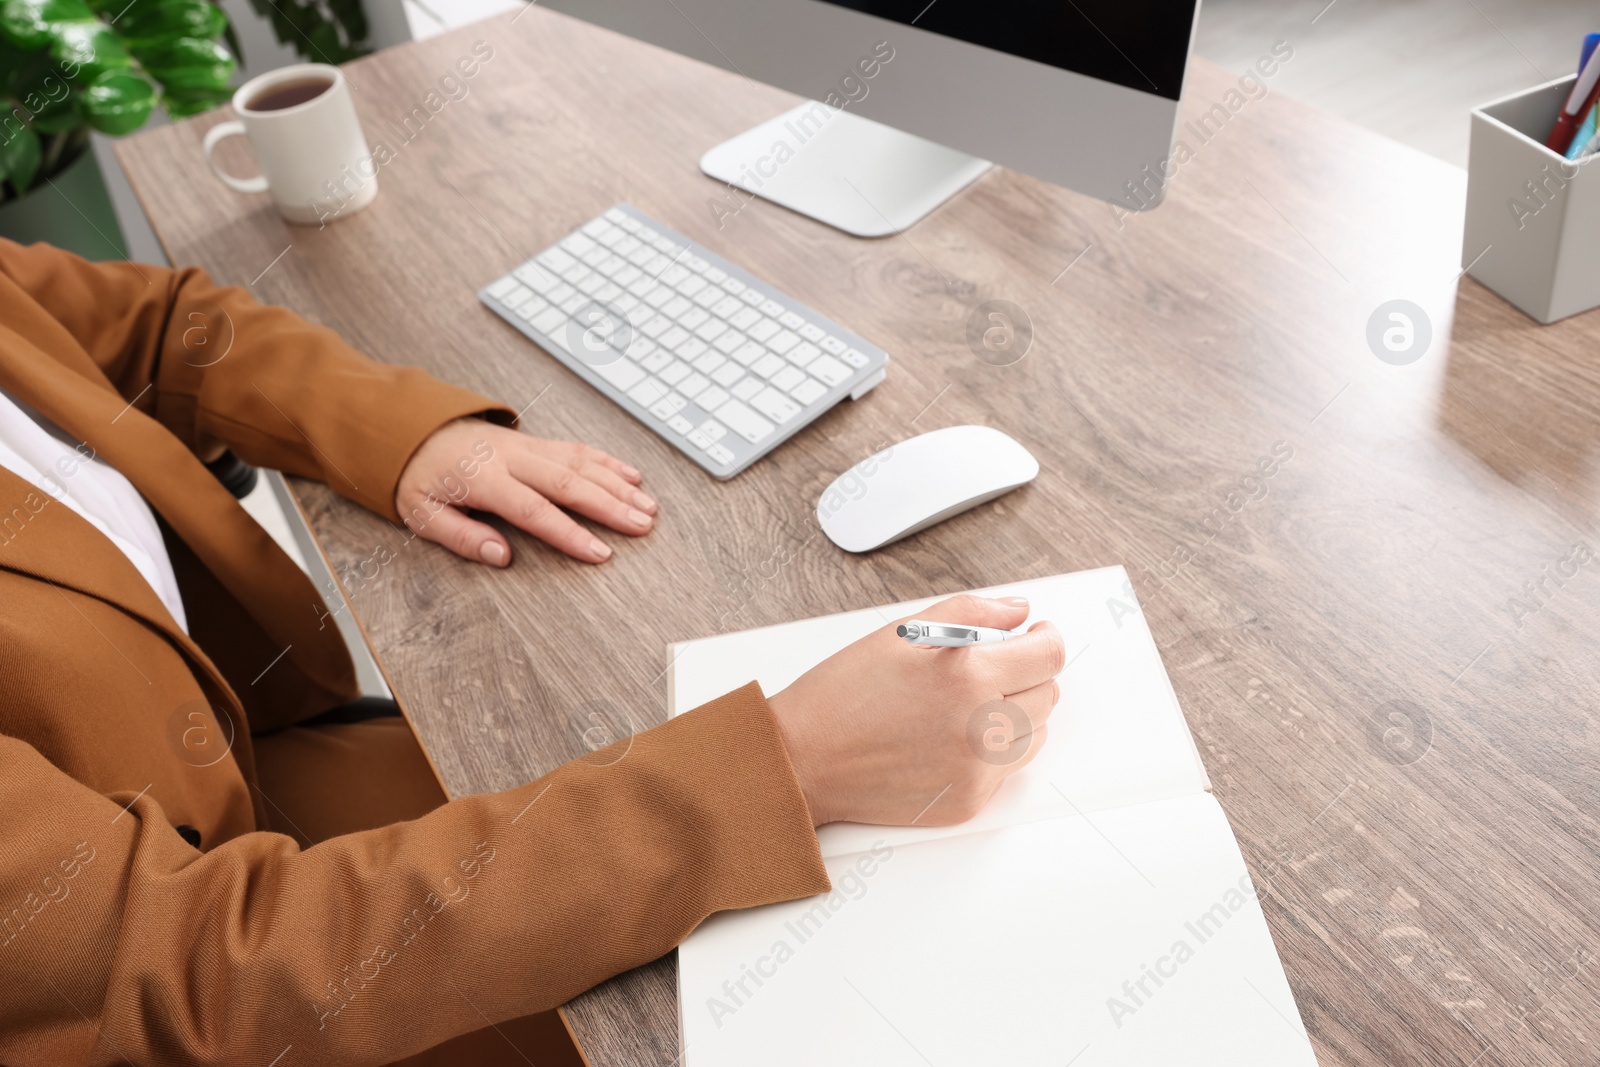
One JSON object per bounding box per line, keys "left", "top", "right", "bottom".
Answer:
{"left": 0, "top": 0, "right": 238, "bottom": 258}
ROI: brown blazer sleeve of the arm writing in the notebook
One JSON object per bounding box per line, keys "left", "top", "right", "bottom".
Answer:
{"left": 0, "top": 683, "right": 829, "bottom": 1067}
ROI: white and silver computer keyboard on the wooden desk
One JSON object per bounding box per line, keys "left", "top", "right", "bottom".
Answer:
{"left": 478, "top": 203, "right": 890, "bottom": 478}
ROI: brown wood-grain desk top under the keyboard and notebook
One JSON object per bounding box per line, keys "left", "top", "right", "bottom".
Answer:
{"left": 120, "top": 8, "right": 1600, "bottom": 1067}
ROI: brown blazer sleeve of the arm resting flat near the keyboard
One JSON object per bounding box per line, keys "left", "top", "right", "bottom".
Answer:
{"left": 0, "top": 240, "right": 515, "bottom": 522}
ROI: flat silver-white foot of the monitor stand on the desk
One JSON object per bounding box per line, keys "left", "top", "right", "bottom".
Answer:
{"left": 701, "top": 101, "right": 990, "bottom": 237}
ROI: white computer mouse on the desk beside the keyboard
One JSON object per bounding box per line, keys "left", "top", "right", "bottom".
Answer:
{"left": 816, "top": 426, "right": 1038, "bottom": 552}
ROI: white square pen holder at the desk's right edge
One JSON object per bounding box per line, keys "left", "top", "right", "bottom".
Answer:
{"left": 1461, "top": 77, "right": 1600, "bottom": 323}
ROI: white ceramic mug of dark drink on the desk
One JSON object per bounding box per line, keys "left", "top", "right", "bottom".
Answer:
{"left": 205, "top": 62, "right": 378, "bottom": 224}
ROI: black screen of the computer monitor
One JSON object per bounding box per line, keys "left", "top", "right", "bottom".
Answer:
{"left": 824, "top": 0, "right": 1197, "bottom": 99}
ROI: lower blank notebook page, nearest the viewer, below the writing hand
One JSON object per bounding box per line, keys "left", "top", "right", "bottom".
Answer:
{"left": 678, "top": 793, "right": 1317, "bottom": 1067}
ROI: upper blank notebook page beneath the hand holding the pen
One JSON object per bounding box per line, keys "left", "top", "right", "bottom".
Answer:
{"left": 669, "top": 566, "right": 1210, "bottom": 856}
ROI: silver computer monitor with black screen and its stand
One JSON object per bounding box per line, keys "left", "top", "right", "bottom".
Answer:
{"left": 542, "top": 0, "right": 1200, "bottom": 237}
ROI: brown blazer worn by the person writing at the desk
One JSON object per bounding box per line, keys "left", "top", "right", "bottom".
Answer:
{"left": 0, "top": 240, "right": 827, "bottom": 1067}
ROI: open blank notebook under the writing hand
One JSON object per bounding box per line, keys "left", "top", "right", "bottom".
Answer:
{"left": 669, "top": 566, "right": 1317, "bottom": 1067}
